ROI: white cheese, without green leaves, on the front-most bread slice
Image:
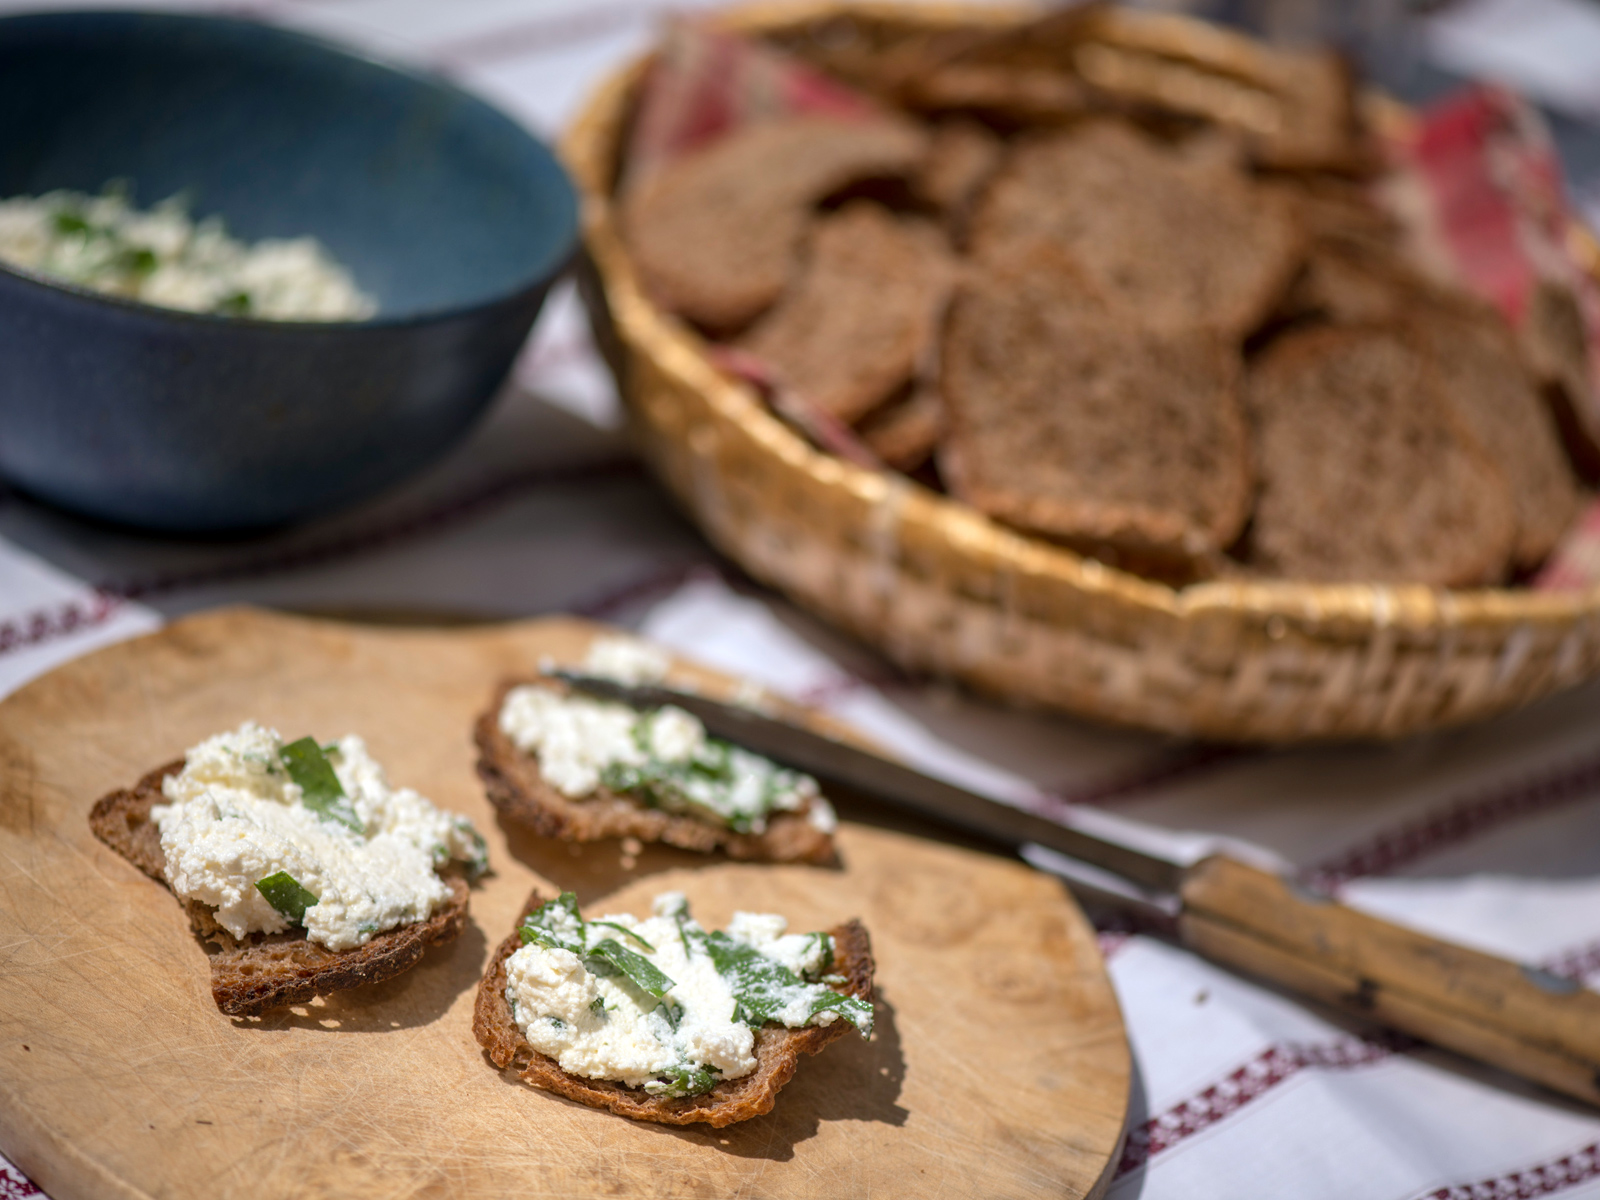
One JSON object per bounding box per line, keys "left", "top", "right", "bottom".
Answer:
{"left": 506, "top": 891, "right": 857, "bottom": 1086}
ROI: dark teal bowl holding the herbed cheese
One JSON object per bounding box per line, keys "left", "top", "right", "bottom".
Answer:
{"left": 0, "top": 11, "right": 576, "bottom": 533}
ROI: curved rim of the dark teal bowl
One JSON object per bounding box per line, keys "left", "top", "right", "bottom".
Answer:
{"left": 0, "top": 8, "right": 581, "bottom": 333}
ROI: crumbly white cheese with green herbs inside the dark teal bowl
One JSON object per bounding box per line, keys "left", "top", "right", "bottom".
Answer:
{"left": 0, "top": 190, "right": 378, "bottom": 322}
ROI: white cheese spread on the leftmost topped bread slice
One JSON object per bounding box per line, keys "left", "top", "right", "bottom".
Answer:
{"left": 150, "top": 722, "right": 483, "bottom": 950}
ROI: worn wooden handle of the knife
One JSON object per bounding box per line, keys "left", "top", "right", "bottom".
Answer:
{"left": 1179, "top": 858, "right": 1600, "bottom": 1104}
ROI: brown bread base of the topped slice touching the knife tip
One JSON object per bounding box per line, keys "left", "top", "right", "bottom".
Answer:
{"left": 474, "top": 678, "right": 835, "bottom": 864}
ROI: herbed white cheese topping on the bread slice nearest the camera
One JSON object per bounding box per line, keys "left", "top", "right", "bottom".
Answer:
{"left": 506, "top": 891, "right": 872, "bottom": 1096}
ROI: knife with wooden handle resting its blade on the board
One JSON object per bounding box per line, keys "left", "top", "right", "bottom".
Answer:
{"left": 550, "top": 670, "right": 1600, "bottom": 1106}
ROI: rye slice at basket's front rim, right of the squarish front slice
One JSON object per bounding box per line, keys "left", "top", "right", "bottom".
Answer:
{"left": 1246, "top": 326, "right": 1517, "bottom": 587}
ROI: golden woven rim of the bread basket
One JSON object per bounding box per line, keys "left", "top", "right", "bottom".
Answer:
{"left": 560, "top": 0, "right": 1600, "bottom": 630}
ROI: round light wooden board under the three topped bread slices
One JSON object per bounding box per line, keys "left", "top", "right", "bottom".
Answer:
{"left": 0, "top": 610, "right": 1130, "bottom": 1200}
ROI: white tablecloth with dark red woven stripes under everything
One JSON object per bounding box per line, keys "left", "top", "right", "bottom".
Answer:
{"left": 0, "top": 0, "right": 1600, "bottom": 1200}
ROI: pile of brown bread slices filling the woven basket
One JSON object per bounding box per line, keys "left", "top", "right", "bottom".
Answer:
{"left": 619, "top": 6, "right": 1586, "bottom": 587}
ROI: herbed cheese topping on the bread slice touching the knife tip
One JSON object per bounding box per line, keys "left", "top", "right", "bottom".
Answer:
{"left": 499, "top": 685, "right": 832, "bottom": 834}
